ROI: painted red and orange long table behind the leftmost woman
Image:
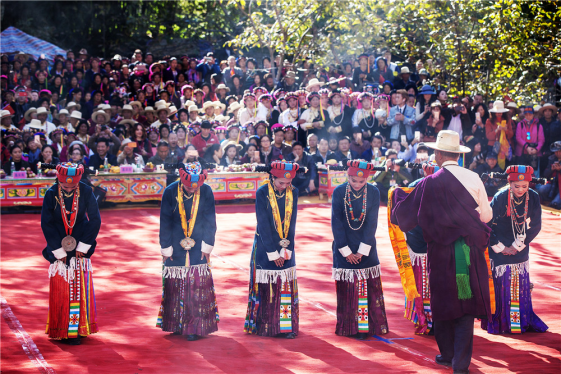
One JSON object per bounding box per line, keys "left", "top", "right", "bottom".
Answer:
{"left": 0, "top": 171, "right": 167, "bottom": 207}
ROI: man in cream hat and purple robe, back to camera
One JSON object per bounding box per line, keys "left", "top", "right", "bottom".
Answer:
{"left": 391, "top": 130, "right": 493, "bottom": 373}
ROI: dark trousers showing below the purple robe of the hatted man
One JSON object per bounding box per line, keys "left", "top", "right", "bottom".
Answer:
{"left": 434, "top": 315, "right": 474, "bottom": 370}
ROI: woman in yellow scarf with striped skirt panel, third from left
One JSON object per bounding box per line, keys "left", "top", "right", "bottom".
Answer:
{"left": 244, "top": 161, "right": 299, "bottom": 339}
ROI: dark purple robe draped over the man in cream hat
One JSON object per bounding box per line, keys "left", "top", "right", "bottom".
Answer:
{"left": 391, "top": 168, "right": 491, "bottom": 321}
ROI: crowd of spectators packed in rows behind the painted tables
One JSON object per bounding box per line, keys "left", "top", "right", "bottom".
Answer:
{"left": 1, "top": 49, "right": 561, "bottom": 208}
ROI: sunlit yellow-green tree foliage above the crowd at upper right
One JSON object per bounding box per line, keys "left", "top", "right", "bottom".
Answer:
{"left": 227, "top": 0, "right": 561, "bottom": 102}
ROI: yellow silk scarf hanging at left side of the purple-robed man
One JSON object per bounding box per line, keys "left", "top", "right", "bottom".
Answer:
{"left": 388, "top": 187, "right": 420, "bottom": 300}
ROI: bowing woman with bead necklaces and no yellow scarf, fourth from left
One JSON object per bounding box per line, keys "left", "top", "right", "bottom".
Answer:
{"left": 331, "top": 160, "right": 388, "bottom": 339}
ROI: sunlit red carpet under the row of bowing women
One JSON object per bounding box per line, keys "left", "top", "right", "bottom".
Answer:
{"left": 0, "top": 204, "right": 561, "bottom": 374}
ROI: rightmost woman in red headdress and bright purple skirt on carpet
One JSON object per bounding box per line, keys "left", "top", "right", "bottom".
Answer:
{"left": 481, "top": 165, "right": 548, "bottom": 334}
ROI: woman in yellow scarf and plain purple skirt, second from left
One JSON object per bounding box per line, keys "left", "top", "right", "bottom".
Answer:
{"left": 157, "top": 162, "right": 219, "bottom": 341}
